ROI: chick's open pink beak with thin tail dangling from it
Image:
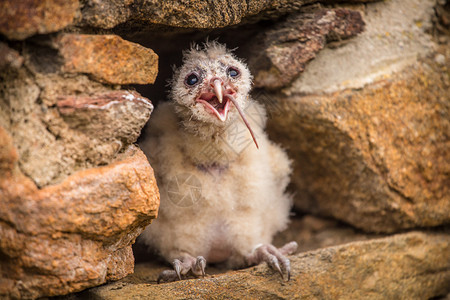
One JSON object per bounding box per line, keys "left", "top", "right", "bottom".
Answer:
{"left": 197, "top": 77, "right": 259, "bottom": 149}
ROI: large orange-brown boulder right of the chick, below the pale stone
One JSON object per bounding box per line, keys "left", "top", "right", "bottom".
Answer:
{"left": 270, "top": 53, "right": 450, "bottom": 232}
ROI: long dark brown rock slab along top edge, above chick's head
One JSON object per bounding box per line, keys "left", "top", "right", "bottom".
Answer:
{"left": 80, "top": 0, "right": 380, "bottom": 30}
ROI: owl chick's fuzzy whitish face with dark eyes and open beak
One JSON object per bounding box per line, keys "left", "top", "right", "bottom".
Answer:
{"left": 171, "top": 42, "right": 252, "bottom": 127}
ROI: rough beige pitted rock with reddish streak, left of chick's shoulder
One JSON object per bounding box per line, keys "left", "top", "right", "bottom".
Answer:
{"left": 0, "top": 54, "right": 153, "bottom": 187}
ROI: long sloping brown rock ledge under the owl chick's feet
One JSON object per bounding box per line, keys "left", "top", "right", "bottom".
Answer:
{"left": 72, "top": 232, "right": 450, "bottom": 299}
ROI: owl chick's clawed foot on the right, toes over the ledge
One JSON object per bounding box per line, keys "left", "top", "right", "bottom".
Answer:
{"left": 247, "top": 242, "right": 298, "bottom": 281}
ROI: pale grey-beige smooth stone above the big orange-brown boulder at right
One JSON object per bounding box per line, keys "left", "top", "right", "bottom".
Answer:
{"left": 287, "top": 0, "right": 436, "bottom": 93}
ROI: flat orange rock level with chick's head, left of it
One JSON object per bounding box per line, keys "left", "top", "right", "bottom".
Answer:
{"left": 55, "top": 34, "right": 158, "bottom": 84}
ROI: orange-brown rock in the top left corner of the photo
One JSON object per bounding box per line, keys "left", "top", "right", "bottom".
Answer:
{"left": 0, "top": 0, "right": 80, "bottom": 40}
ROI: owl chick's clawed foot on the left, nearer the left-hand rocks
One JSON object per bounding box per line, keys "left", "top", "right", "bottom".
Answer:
{"left": 157, "top": 256, "right": 206, "bottom": 283}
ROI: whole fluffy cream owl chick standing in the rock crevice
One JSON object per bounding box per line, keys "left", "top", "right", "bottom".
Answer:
{"left": 140, "top": 42, "right": 297, "bottom": 282}
